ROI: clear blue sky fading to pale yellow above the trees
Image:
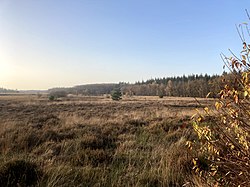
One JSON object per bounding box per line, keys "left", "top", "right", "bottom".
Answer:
{"left": 0, "top": 0, "right": 250, "bottom": 90}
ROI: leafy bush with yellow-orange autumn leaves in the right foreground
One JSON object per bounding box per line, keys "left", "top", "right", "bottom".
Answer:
{"left": 187, "top": 21, "right": 250, "bottom": 186}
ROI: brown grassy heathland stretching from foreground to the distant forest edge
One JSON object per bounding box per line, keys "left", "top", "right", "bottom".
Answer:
{"left": 0, "top": 95, "right": 212, "bottom": 187}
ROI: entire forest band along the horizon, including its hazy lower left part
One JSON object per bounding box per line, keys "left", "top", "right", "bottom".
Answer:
{"left": 48, "top": 72, "right": 230, "bottom": 97}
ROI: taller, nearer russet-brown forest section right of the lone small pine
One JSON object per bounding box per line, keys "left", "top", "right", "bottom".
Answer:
{"left": 123, "top": 73, "right": 225, "bottom": 97}
